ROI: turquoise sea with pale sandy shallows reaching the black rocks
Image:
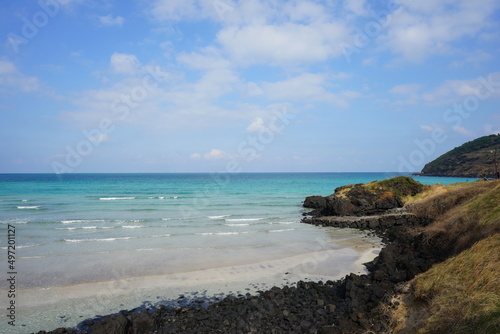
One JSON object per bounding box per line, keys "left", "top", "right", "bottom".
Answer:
{"left": 0, "top": 173, "right": 474, "bottom": 333}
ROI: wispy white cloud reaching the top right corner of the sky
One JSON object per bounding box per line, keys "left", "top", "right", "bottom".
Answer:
{"left": 382, "top": 0, "right": 500, "bottom": 62}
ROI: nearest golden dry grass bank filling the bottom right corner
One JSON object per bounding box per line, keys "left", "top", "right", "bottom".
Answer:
{"left": 414, "top": 234, "right": 500, "bottom": 334}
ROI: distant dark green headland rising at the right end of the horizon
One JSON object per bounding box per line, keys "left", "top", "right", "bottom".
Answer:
{"left": 418, "top": 134, "right": 500, "bottom": 178}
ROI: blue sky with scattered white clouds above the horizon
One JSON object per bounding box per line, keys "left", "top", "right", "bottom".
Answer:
{"left": 0, "top": 0, "right": 500, "bottom": 174}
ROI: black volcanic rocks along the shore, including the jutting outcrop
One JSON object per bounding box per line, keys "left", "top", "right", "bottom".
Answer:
{"left": 38, "top": 177, "right": 472, "bottom": 334}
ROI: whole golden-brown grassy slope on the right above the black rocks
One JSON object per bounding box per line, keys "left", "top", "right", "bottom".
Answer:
{"left": 391, "top": 181, "right": 500, "bottom": 334}
